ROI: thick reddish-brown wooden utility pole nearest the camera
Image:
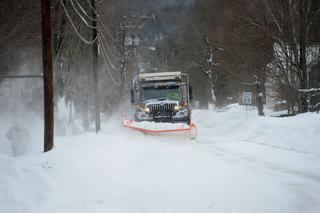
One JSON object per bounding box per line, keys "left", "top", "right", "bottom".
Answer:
{"left": 41, "top": 0, "right": 54, "bottom": 152}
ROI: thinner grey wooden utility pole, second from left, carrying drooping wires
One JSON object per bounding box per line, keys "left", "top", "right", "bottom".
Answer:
{"left": 91, "top": 0, "right": 101, "bottom": 133}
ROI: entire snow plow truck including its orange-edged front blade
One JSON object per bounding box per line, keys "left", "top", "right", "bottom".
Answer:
{"left": 123, "top": 72, "right": 196, "bottom": 139}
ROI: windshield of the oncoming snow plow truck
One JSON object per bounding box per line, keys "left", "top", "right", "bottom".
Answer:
{"left": 141, "top": 86, "right": 182, "bottom": 101}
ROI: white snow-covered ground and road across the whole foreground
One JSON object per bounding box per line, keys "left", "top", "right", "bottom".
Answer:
{"left": 0, "top": 105, "right": 320, "bottom": 213}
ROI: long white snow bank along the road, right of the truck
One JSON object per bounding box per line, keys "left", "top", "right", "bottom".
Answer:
{"left": 193, "top": 104, "right": 320, "bottom": 155}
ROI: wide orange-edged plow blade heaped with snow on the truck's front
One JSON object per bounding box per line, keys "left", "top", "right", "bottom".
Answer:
{"left": 121, "top": 119, "right": 197, "bottom": 139}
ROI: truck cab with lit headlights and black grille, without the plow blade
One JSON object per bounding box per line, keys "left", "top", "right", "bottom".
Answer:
{"left": 131, "top": 72, "right": 192, "bottom": 124}
